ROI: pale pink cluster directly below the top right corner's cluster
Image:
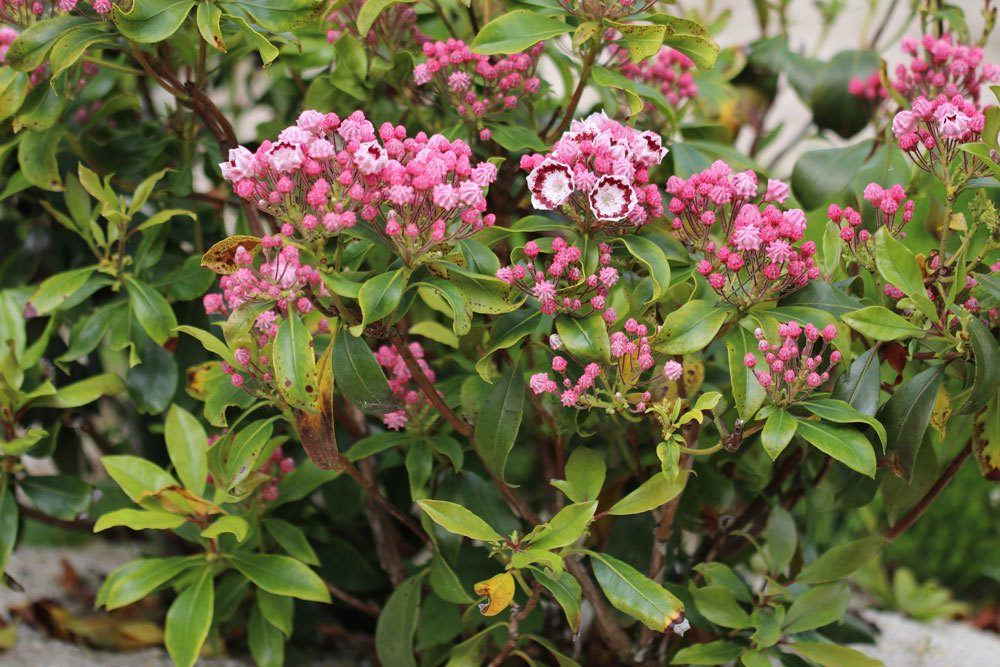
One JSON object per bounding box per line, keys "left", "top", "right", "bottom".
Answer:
{"left": 892, "top": 95, "right": 986, "bottom": 173}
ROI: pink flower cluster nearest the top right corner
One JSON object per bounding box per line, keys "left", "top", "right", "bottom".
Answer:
{"left": 892, "top": 34, "right": 1000, "bottom": 103}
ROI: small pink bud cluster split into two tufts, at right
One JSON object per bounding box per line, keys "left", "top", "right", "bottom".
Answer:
{"left": 826, "top": 183, "right": 914, "bottom": 270}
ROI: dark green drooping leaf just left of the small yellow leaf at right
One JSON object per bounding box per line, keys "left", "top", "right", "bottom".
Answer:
{"left": 878, "top": 366, "right": 943, "bottom": 481}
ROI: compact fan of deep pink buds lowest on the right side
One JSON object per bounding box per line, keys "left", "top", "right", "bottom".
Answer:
{"left": 743, "top": 322, "right": 841, "bottom": 405}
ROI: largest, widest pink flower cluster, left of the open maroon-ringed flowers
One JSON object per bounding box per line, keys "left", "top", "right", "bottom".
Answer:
{"left": 219, "top": 111, "right": 497, "bottom": 264}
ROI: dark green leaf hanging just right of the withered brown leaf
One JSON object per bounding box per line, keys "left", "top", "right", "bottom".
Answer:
{"left": 332, "top": 330, "right": 402, "bottom": 415}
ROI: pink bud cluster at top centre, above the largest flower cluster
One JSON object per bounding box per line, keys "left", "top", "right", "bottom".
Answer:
{"left": 413, "top": 39, "right": 545, "bottom": 122}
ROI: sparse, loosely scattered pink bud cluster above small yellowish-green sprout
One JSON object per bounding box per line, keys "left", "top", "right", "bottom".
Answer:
{"left": 528, "top": 318, "right": 684, "bottom": 413}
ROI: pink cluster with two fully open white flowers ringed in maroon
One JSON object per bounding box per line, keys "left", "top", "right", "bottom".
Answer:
{"left": 521, "top": 113, "right": 667, "bottom": 234}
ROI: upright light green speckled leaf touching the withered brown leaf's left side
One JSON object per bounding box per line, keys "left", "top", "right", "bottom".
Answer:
{"left": 271, "top": 312, "right": 319, "bottom": 412}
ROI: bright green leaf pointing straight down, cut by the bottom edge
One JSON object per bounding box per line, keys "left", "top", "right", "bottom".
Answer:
{"left": 163, "top": 565, "right": 215, "bottom": 667}
